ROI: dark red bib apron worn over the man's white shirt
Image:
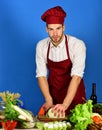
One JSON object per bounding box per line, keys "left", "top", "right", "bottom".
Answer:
{"left": 47, "top": 36, "right": 86, "bottom": 114}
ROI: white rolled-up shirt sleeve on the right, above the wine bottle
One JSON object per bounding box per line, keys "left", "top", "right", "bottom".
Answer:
{"left": 71, "top": 40, "right": 86, "bottom": 78}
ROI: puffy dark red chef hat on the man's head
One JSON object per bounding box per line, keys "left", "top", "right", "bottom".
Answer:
{"left": 41, "top": 6, "right": 66, "bottom": 24}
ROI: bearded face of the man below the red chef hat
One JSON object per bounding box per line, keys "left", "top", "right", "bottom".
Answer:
{"left": 46, "top": 24, "right": 65, "bottom": 46}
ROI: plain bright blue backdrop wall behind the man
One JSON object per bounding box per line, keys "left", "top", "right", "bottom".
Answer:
{"left": 0, "top": 0, "right": 102, "bottom": 115}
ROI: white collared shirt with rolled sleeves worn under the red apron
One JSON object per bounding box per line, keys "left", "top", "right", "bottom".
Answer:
{"left": 36, "top": 35, "right": 86, "bottom": 77}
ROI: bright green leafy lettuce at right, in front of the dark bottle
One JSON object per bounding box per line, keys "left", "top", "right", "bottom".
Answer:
{"left": 69, "top": 100, "right": 93, "bottom": 130}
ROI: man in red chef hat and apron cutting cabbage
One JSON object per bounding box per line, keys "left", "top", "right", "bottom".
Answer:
{"left": 36, "top": 6, "right": 86, "bottom": 115}
